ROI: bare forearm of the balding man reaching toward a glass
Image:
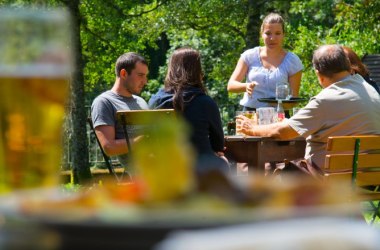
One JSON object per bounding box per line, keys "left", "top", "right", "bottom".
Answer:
{"left": 237, "top": 116, "right": 299, "bottom": 140}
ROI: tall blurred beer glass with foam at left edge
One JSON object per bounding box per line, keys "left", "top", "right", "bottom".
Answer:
{"left": 0, "top": 9, "right": 72, "bottom": 193}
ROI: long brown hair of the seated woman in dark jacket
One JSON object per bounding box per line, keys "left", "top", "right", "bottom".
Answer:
{"left": 165, "top": 47, "right": 206, "bottom": 111}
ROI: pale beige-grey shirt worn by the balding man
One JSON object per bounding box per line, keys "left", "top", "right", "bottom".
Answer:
{"left": 287, "top": 74, "right": 380, "bottom": 168}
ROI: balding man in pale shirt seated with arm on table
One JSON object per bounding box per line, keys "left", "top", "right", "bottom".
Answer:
{"left": 238, "top": 45, "right": 380, "bottom": 168}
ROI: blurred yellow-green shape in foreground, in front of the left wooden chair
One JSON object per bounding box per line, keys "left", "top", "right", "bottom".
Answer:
{"left": 132, "top": 116, "right": 195, "bottom": 203}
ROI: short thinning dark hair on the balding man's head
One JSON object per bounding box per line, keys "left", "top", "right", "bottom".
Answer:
{"left": 313, "top": 44, "right": 351, "bottom": 77}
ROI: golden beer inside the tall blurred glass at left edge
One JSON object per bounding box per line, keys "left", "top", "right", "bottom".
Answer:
{"left": 0, "top": 78, "right": 68, "bottom": 192}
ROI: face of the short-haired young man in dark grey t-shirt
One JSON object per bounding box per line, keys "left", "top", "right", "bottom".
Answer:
{"left": 122, "top": 62, "right": 149, "bottom": 95}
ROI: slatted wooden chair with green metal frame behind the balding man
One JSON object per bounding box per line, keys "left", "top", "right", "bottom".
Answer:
{"left": 324, "top": 135, "right": 380, "bottom": 224}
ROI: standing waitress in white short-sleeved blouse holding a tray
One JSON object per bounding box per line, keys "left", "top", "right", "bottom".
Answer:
{"left": 227, "top": 13, "right": 303, "bottom": 110}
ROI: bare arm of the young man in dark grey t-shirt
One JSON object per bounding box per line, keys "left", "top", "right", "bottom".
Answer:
{"left": 95, "top": 125, "right": 129, "bottom": 156}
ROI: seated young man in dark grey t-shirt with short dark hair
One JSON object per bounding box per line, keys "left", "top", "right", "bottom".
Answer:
{"left": 91, "top": 52, "right": 148, "bottom": 171}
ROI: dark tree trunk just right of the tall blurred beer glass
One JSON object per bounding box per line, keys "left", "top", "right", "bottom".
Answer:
{"left": 66, "top": 0, "right": 91, "bottom": 183}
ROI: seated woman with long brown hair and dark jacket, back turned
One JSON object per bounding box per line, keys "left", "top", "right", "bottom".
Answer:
{"left": 148, "top": 47, "right": 229, "bottom": 172}
